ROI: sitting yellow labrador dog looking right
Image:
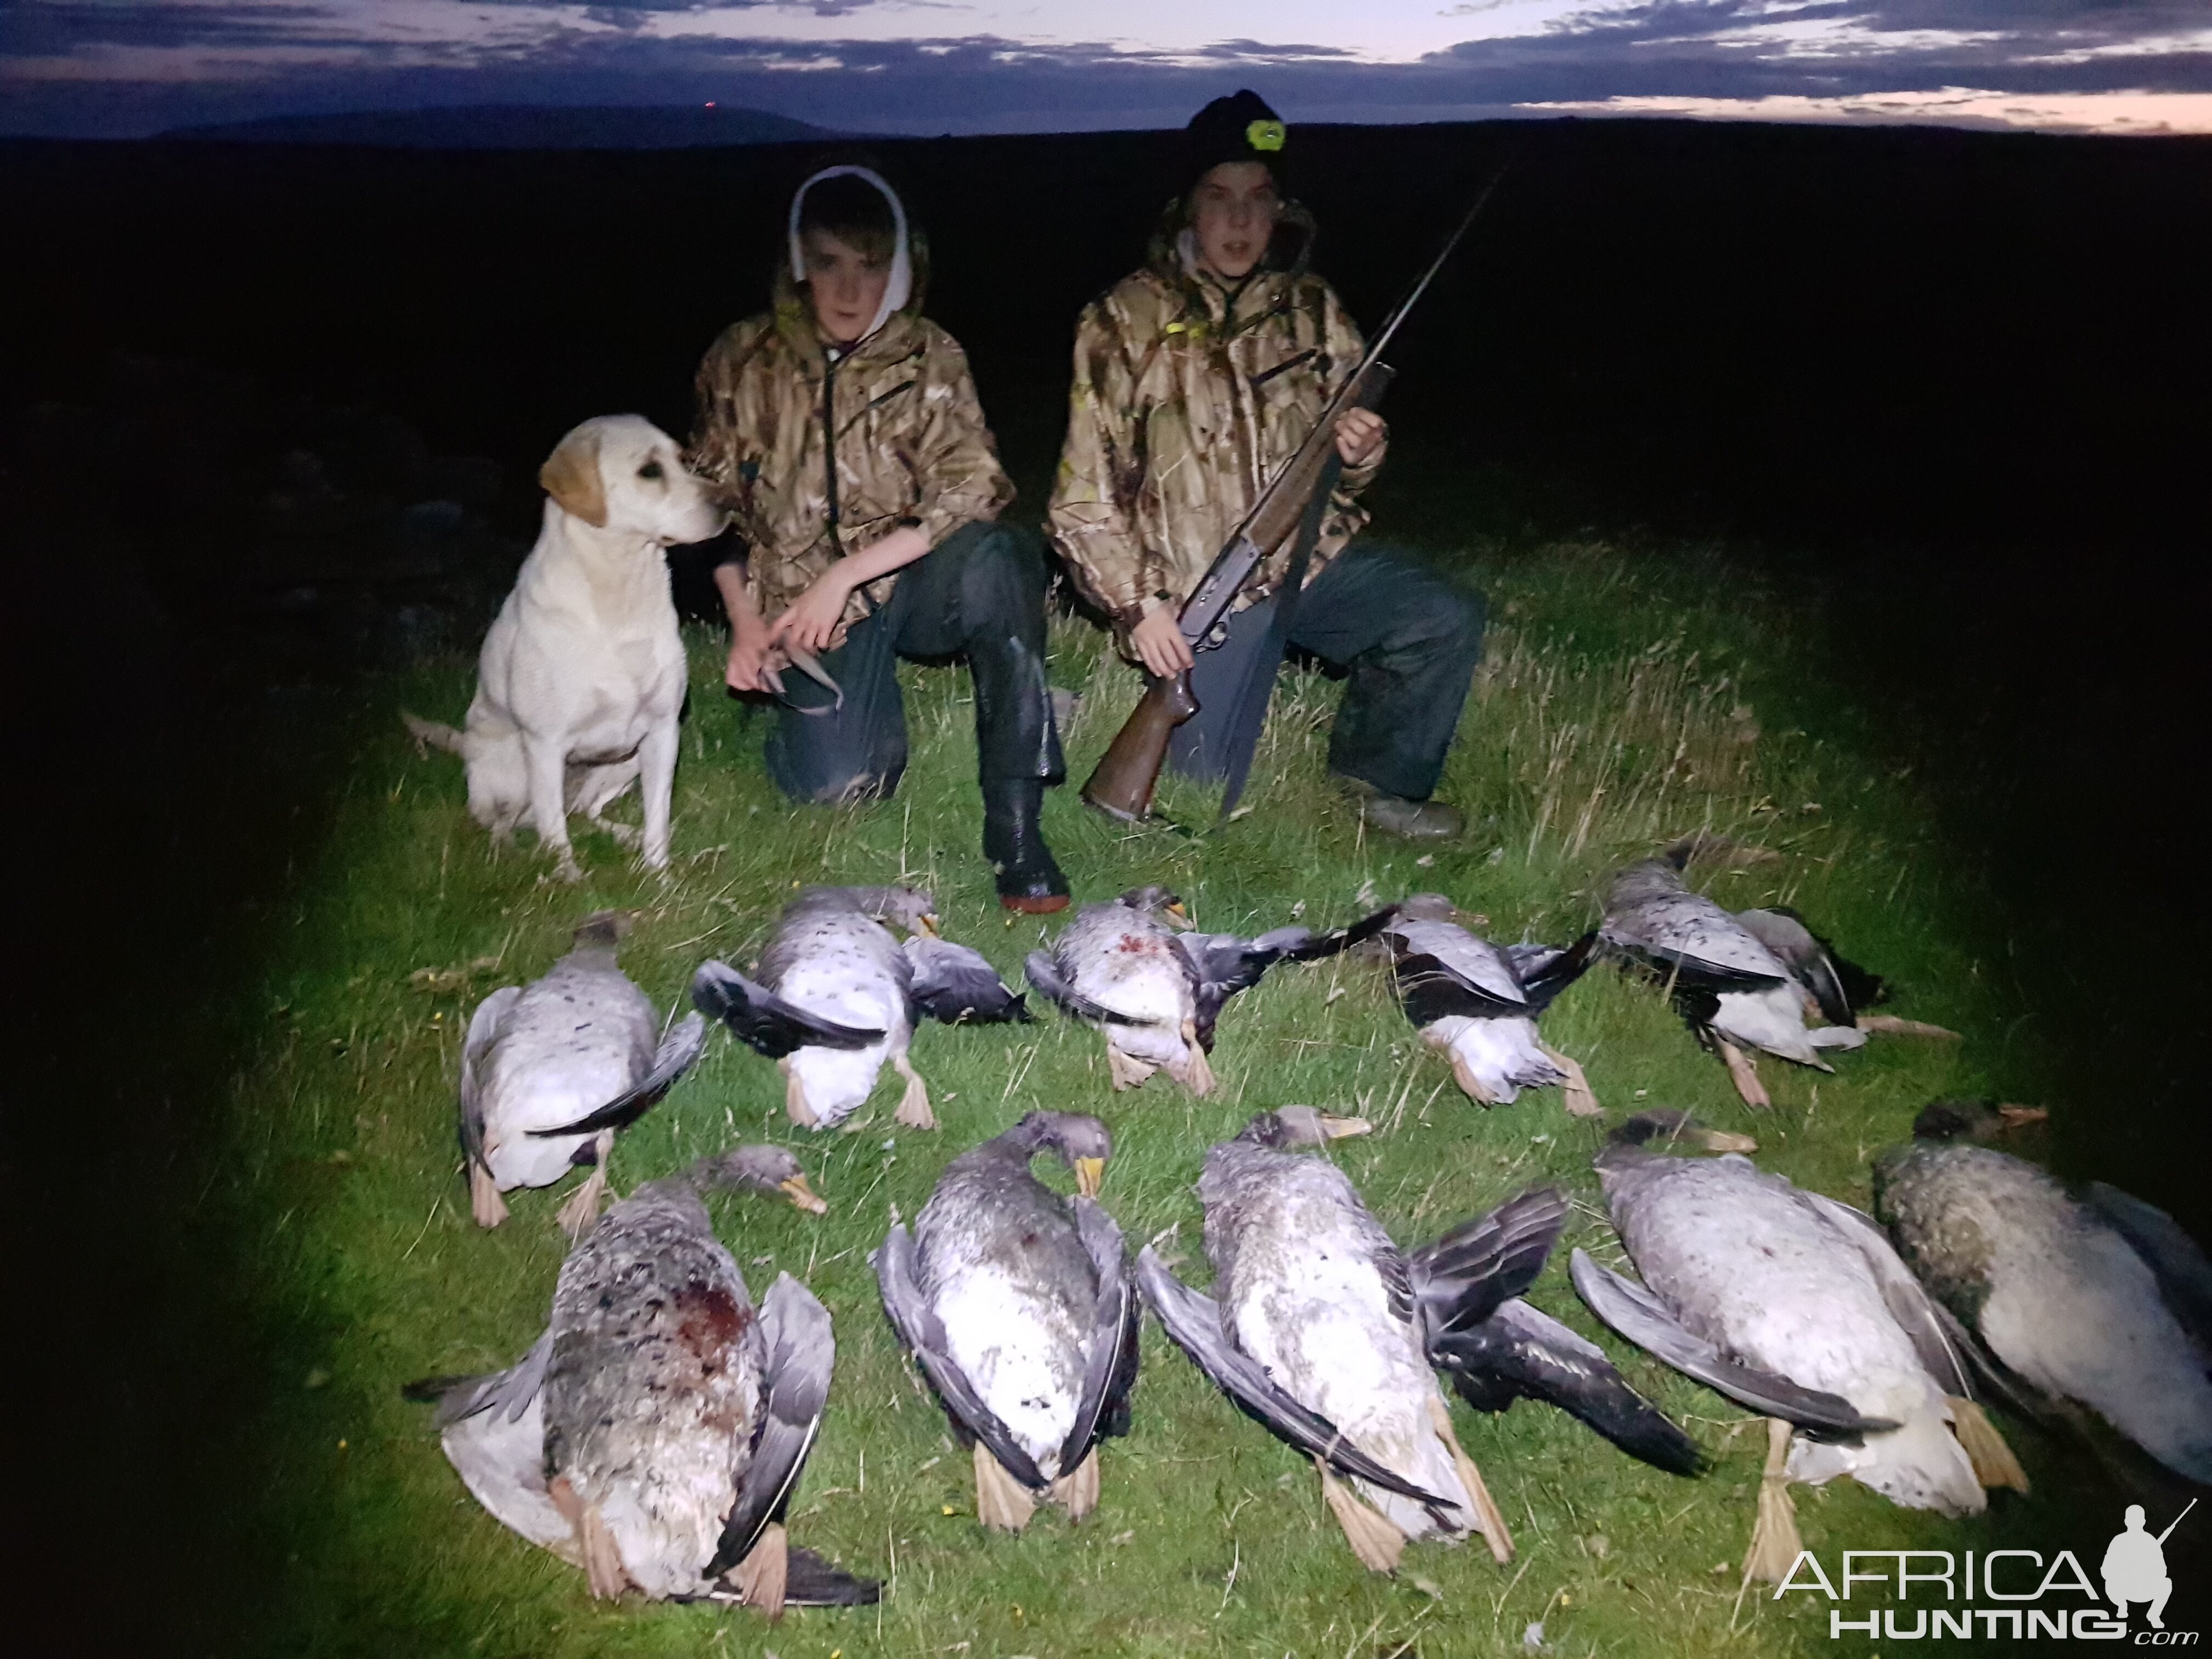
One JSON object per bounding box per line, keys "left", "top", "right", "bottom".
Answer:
{"left": 403, "top": 416, "right": 723, "bottom": 881}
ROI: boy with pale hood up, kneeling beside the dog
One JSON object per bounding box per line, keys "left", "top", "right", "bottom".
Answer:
{"left": 690, "top": 166, "right": 1068, "bottom": 911}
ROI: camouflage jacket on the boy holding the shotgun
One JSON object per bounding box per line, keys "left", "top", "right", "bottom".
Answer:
{"left": 1051, "top": 208, "right": 1383, "bottom": 630}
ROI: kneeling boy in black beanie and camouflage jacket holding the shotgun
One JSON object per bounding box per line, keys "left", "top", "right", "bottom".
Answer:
{"left": 1051, "top": 91, "right": 1482, "bottom": 838}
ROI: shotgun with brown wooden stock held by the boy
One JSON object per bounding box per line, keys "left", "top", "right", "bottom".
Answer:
{"left": 1082, "top": 168, "right": 1504, "bottom": 823}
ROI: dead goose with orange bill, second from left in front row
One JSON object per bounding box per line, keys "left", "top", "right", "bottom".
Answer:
{"left": 876, "top": 1113, "right": 1139, "bottom": 1533}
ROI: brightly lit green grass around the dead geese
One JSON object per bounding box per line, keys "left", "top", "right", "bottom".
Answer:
{"left": 201, "top": 546, "right": 2124, "bottom": 1659}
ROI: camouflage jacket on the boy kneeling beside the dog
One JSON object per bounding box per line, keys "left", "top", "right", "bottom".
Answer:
{"left": 688, "top": 204, "right": 1013, "bottom": 648}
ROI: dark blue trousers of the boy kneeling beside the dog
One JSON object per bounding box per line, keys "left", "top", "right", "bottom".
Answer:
{"left": 768, "top": 522, "right": 1066, "bottom": 801}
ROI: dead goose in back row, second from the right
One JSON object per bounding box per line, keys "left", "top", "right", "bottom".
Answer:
{"left": 1345, "top": 894, "right": 1599, "bottom": 1117}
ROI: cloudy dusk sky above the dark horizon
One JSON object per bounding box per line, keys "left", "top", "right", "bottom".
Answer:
{"left": 0, "top": 0, "right": 2212, "bottom": 137}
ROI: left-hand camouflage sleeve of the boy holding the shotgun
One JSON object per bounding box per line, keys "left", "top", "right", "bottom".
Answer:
{"left": 1048, "top": 301, "right": 1150, "bottom": 626}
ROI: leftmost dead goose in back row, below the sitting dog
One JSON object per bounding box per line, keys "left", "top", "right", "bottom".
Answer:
{"left": 460, "top": 911, "right": 706, "bottom": 1237}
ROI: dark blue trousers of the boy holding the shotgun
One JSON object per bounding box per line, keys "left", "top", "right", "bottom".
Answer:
{"left": 1168, "top": 542, "right": 1484, "bottom": 801}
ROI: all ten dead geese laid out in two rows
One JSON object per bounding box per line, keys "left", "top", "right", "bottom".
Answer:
{"left": 409, "top": 843, "right": 2212, "bottom": 1617}
